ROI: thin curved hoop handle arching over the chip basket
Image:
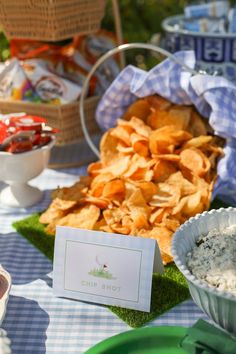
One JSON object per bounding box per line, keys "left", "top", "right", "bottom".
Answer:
{"left": 79, "top": 43, "right": 197, "bottom": 158}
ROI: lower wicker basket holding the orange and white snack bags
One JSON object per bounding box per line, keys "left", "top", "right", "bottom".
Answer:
{"left": 0, "top": 96, "right": 100, "bottom": 146}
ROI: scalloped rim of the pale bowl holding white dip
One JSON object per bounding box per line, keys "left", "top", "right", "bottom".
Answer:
{"left": 171, "top": 207, "right": 236, "bottom": 302}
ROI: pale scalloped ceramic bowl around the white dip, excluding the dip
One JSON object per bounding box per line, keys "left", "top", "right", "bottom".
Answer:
{"left": 172, "top": 207, "right": 236, "bottom": 336}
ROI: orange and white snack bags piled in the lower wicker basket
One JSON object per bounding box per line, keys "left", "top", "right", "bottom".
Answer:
{"left": 0, "top": 30, "right": 120, "bottom": 104}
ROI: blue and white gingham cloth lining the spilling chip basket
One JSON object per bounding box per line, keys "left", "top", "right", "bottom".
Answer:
{"left": 96, "top": 51, "right": 236, "bottom": 205}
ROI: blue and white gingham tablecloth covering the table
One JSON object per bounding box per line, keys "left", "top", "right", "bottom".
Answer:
{"left": 0, "top": 166, "right": 207, "bottom": 354}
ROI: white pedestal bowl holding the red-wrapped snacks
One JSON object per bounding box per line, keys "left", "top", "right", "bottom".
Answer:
{"left": 0, "top": 136, "right": 55, "bottom": 207}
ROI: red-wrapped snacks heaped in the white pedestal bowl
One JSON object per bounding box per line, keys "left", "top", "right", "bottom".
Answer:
{"left": 0, "top": 114, "right": 57, "bottom": 153}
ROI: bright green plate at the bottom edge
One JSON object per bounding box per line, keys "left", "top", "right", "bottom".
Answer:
{"left": 85, "top": 326, "right": 187, "bottom": 354}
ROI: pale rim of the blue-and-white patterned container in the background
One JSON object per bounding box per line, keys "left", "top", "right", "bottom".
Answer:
{"left": 161, "top": 15, "right": 236, "bottom": 39}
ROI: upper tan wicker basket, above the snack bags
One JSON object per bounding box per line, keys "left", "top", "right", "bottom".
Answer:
{"left": 0, "top": 0, "right": 105, "bottom": 41}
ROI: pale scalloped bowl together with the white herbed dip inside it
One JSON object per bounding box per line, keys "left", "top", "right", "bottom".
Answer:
{"left": 172, "top": 207, "right": 236, "bottom": 336}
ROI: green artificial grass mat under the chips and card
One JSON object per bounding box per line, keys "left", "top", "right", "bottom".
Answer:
{"left": 13, "top": 213, "right": 190, "bottom": 328}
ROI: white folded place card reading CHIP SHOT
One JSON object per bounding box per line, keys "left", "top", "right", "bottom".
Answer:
{"left": 53, "top": 226, "right": 163, "bottom": 312}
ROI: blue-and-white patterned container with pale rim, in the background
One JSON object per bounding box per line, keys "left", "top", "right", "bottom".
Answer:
{"left": 162, "top": 15, "right": 236, "bottom": 84}
